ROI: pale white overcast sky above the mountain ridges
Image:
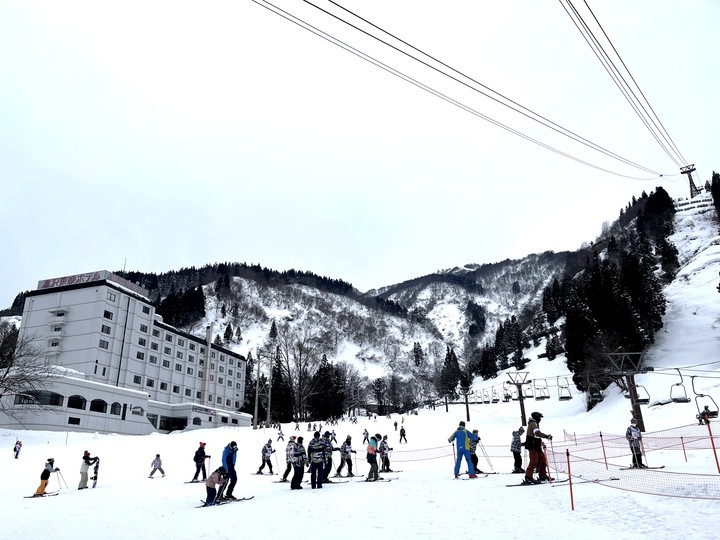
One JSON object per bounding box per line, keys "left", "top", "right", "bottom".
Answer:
{"left": 0, "top": 0, "right": 720, "bottom": 306}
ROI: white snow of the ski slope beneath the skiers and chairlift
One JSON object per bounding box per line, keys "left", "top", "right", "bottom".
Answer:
{"left": 0, "top": 200, "right": 720, "bottom": 540}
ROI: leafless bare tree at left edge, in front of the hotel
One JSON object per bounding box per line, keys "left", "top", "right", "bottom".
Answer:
{"left": 0, "top": 321, "right": 55, "bottom": 420}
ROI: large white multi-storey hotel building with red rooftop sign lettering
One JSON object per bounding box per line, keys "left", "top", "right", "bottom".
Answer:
{"left": 0, "top": 271, "right": 252, "bottom": 435}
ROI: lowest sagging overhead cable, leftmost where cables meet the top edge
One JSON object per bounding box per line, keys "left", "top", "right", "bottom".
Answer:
{"left": 252, "top": 0, "right": 663, "bottom": 181}
